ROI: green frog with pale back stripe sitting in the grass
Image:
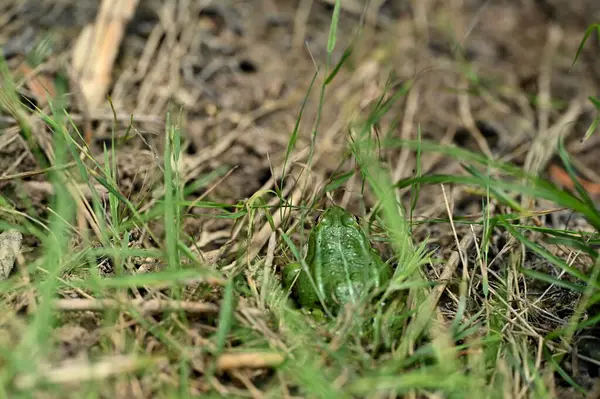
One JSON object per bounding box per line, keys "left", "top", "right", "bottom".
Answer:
{"left": 283, "top": 206, "right": 393, "bottom": 312}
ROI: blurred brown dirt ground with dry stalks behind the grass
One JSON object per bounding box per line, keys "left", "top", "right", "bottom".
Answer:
{"left": 0, "top": 0, "right": 600, "bottom": 209}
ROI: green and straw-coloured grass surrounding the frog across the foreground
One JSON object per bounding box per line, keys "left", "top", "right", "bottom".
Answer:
{"left": 0, "top": 1, "right": 600, "bottom": 398}
